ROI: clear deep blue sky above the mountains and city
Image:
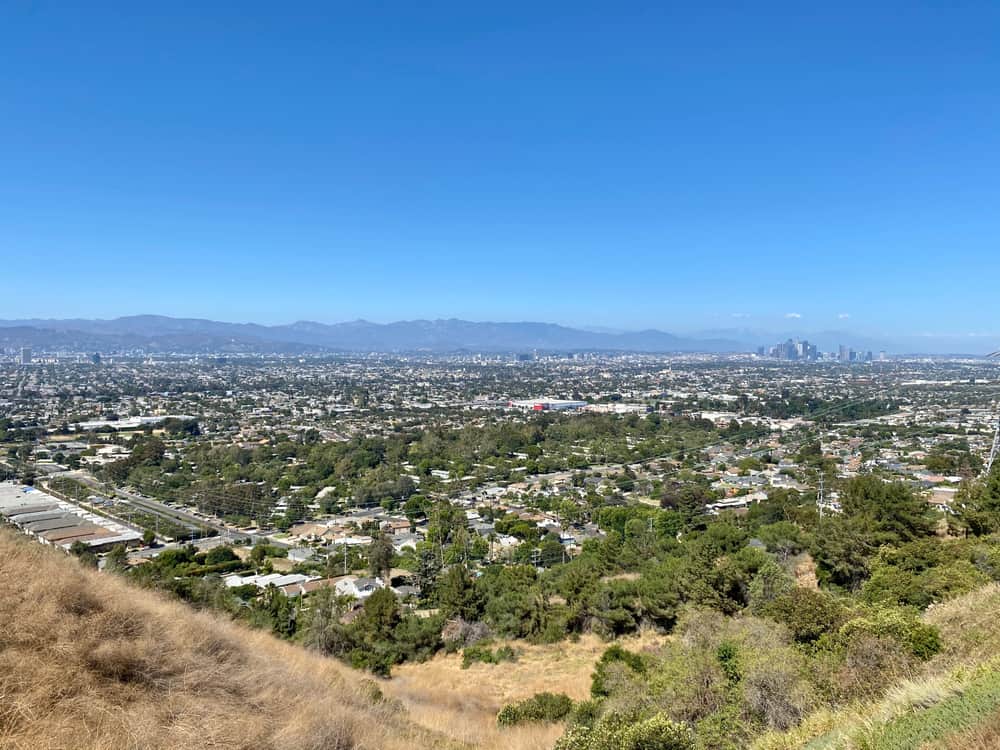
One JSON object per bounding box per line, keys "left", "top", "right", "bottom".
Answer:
{"left": 0, "top": 0, "right": 1000, "bottom": 333}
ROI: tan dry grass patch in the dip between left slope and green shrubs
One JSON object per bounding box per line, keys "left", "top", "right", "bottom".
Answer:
{"left": 381, "top": 634, "right": 664, "bottom": 750}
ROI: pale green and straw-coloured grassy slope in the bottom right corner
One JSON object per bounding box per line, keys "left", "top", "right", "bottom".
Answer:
{"left": 754, "top": 585, "right": 1000, "bottom": 750}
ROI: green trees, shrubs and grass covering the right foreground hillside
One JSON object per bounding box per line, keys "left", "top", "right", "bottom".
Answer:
{"left": 532, "top": 474, "right": 1000, "bottom": 750}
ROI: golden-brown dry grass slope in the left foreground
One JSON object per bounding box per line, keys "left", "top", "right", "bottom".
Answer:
{"left": 0, "top": 530, "right": 454, "bottom": 750}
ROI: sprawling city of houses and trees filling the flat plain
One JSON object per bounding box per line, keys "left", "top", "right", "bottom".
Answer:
{"left": 0, "top": 342, "right": 1000, "bottom": 564}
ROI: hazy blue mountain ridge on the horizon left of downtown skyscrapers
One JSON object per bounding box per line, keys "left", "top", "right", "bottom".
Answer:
{"left": 0, "top": 315, "right": 746, "bottom": 353}
